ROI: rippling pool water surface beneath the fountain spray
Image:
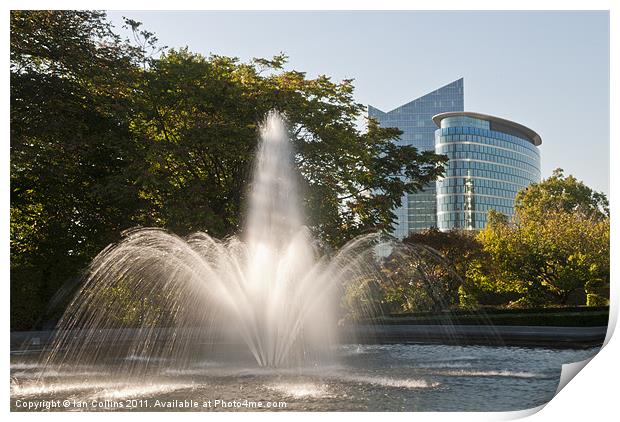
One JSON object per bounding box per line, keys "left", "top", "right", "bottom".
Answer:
{"left": 11, "top": 344, "right": 598, "bottom": 411}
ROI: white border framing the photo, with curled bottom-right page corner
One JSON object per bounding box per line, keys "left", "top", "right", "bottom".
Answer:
{"left": 0, "top": 0, "right": 620, "bottom": 421}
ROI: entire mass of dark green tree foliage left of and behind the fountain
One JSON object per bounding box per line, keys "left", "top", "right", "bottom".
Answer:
{"left": 11, "top": 11, "right": 445, "bottom": 329}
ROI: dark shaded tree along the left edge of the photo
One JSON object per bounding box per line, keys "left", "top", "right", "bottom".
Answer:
{"left": 11, "top": 11, "right": 150, "bottom": 329}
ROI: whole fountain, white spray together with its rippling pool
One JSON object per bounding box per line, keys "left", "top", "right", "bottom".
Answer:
{"left": 11, "top": 112, "right": 592, "bottom": 411}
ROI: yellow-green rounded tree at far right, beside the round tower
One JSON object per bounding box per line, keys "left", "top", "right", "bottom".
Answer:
{"left": 478, "top": 169, "right": 610, "bottom": 306}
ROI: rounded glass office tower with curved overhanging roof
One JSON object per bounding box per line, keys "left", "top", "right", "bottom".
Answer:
{"left": 433, "top": 111, "right": 542, "bottom": 231}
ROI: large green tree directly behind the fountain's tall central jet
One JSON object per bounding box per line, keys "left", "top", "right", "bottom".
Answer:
{"left": 134, "top": 49, "right": 445, "bottom": 246}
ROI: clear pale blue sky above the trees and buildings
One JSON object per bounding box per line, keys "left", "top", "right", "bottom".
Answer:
{"left": 108, "top": 11, "right": 609, "bottom": 194}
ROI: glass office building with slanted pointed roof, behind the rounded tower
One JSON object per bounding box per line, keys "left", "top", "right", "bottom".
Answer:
{"left": 368, "top": 78, "right": 464, "bottom": 239}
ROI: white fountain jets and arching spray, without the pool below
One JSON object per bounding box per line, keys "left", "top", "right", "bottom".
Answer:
{"left": 40, "top": 112, "right": 406, "bottom": 373}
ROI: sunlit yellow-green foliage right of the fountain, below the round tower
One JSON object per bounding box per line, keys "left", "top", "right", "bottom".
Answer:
{"left": 400, "top": 169, "right": 610, "bottom": 307}
